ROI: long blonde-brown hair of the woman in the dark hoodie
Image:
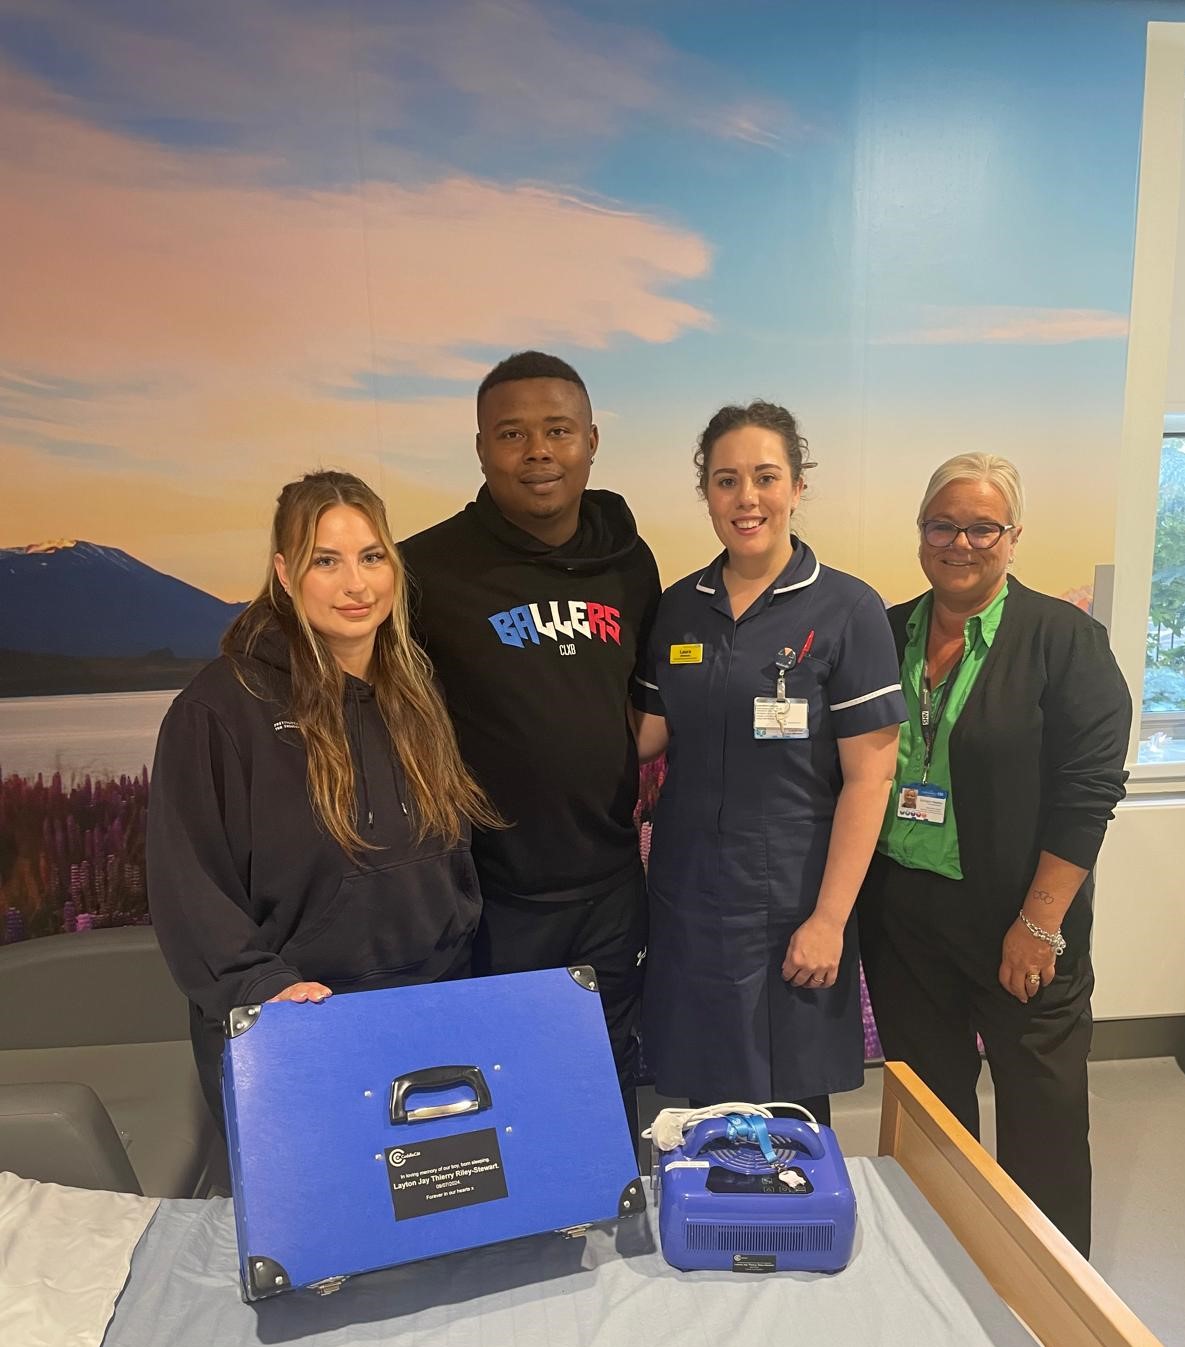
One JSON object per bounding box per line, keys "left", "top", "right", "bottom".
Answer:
{"left": 222, "top": 471, "right": 505, "bottom": 855}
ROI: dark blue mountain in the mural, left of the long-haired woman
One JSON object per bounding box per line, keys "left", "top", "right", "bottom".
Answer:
{"left": 0, "top": 540, "right": 245, "bottom": 661}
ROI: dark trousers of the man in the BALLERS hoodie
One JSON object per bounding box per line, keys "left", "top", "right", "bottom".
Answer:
{"left": 473, "top": 861, "right": 646, "bottom": 1141}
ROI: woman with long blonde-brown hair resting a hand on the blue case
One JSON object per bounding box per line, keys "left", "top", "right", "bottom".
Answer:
{"left": 147, "top": 471, "right": 500, "bottom": 1118}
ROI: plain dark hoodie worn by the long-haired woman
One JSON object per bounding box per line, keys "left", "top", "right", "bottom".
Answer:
{"left": 147, "top": 626, "right": 481, "bottom": 1032}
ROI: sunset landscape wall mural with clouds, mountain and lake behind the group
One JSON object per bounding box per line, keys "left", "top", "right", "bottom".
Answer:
{"left": 0, "top": 0, "right": 1185, "bottom": 1050}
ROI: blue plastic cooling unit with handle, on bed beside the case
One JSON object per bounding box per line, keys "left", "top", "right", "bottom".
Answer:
{"left": 657, "top": 1118, "right": 856, "bottom": 1272}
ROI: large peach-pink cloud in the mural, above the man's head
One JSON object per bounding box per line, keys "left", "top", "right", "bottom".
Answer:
{"left": 0, "top": 67, "right": 710, "bottom": 393}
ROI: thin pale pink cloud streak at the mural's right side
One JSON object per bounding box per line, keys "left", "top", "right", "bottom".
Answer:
{"left": 877, "top": 304, "right": 1127, "bottom": 346}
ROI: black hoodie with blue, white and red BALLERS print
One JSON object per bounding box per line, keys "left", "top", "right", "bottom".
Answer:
{"left": 400, "top": 486, "right": 661, "bottom": 901}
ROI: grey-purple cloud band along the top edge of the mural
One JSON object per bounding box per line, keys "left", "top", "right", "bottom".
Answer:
{"left": 0, "top": 0, "right": 804, "bottom": 162}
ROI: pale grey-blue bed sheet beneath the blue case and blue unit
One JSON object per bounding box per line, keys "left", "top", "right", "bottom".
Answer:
{"left": 104, "top": 1158, "right": 1033, "bottom": 1347}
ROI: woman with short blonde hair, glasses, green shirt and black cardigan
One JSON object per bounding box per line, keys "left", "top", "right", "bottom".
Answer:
{"left": 858, "top": 454, "right": 1131, "bottom": 1254}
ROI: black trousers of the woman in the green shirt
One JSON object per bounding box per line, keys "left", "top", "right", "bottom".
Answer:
{"left": 858, "top": 855, "right": 1095, "bottom": 1255}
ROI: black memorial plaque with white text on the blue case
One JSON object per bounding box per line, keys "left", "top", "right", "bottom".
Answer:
{"left": 385, "top": 1127, "right": 506, "bottom": 1220}
